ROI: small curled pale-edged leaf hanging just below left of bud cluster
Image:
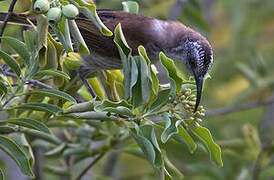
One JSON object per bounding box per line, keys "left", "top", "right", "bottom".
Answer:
{"left": 161, "top": 112, "right": 181, "bottom": 143}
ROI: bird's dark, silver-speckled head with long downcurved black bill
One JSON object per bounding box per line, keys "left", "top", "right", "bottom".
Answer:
{"left": 169, "top": 32, "right": 213, "bottom": 112}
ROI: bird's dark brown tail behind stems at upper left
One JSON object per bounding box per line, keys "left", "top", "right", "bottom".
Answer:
{"left": 0, "top": 12, "right": 35, "bottom": 26}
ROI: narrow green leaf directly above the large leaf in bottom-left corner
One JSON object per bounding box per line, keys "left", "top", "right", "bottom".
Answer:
{"left": 5, "top": 118, "right": 51, "bottom": 134}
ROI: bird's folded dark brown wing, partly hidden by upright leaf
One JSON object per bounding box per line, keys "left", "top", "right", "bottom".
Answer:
{"left": 76, "top": 10, "right": 162, "bottom": 58}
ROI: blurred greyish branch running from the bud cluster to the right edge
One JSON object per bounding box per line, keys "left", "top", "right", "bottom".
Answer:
{"left": 206, "top": 95, "right": 274, "bottom": 117}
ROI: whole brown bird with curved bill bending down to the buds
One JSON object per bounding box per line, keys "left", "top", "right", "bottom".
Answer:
{"left": 0, "top": 10, "right": 213, "bottom": 111}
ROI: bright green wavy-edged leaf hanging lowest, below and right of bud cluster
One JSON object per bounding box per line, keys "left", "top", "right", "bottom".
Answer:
{"left": 188, "top": 123, "right": 223, "bottom": 166}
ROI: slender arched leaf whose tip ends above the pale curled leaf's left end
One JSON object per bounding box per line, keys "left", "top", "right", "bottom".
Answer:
{"left": 29, "top": 89, "right": 76, "bottom": 103}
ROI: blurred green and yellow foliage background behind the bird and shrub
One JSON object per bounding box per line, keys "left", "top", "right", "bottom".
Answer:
{"left": 0, "top": 0, "right": 274, "bottom": 180}
